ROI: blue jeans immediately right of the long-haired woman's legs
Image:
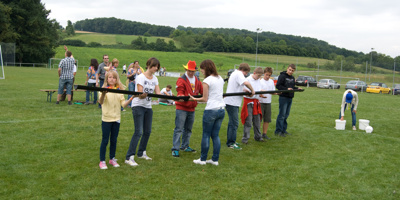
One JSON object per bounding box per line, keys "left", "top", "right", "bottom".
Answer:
{"left": 226, "top": 105, "right": 239, "bottom": 147}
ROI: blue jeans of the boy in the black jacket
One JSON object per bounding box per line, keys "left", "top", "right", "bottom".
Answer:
{"left": 275, "top": 96, "right": 293, "bottom": 133}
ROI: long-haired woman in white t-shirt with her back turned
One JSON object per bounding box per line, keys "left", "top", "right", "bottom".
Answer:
{"left": 189, "top": 60, "right": 225, "bottom": 166}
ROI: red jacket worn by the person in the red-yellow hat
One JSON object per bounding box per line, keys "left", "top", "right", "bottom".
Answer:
{"left": 175, "top": 74, "right": 203, "bottom": 112}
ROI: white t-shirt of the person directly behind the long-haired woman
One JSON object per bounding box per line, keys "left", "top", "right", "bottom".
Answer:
{"left": 224, "top": 70, "right": 246, "bottom": 107}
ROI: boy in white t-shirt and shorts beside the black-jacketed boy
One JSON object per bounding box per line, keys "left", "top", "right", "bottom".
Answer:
{"left": 260, "top": 67, "right": 275, "bottom": 140}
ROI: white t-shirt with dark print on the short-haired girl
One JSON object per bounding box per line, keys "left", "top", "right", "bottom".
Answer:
{"left": 131, "top": 74, "right": 158, "bottom": 108}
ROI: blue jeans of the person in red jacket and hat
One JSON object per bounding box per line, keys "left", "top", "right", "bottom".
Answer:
{"left": 171, "top": 109, "right": 194, "bottom": 151}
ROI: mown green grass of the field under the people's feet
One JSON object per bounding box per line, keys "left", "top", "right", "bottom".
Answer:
{"left": 0, "top": 66, "right": 400, "bottom": 200}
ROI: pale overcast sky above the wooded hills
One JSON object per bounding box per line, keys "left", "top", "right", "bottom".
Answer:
{"left": 42, "top": 0, "right": 400, "bottom": 58}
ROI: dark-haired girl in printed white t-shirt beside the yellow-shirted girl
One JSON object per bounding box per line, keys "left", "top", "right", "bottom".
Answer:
{"left": 125, "top": 58, "right": 160, "bottom": 166}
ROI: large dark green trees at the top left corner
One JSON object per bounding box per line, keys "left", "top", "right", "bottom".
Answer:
{"left": 0, "top": 0, "right": 60, "bottom": 63}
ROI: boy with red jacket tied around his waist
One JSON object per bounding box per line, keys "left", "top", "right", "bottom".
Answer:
{"left": 241, "top": 67, "right": 265, "bottom": 144}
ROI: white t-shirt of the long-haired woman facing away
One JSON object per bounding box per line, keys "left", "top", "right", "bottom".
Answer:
{"left": 203, "top": 76, "right": 225, "bottom": 110}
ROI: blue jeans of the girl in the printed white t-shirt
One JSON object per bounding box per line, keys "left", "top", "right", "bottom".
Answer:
{"left": 126, "top": 106, "right": 153, "bottom": 160}
